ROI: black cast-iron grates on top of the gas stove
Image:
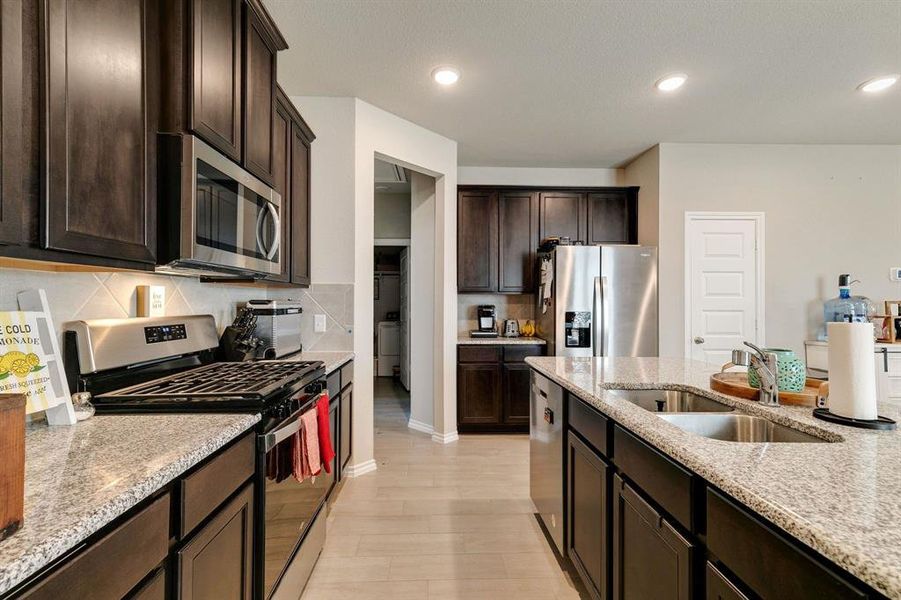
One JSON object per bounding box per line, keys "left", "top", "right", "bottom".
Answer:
{"left": 102, "top": 361, "right": 321, "bottom": 399}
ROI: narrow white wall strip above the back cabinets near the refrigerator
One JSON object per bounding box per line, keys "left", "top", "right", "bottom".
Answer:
{"left": 457, "top": 167, "right": 619, "bottom": 187}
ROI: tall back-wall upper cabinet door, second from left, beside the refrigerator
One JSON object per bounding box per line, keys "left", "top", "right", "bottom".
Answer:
{"left": 497, "top": 191, "right": 538, "bottom": 293}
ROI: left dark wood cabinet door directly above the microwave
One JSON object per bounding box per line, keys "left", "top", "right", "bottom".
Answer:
{"left": 188, "top": 0, "right": 243, "bottom": 160}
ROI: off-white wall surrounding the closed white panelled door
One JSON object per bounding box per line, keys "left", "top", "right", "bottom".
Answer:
{"left": 659, "top": 144, "right": 901, "bottom": 356}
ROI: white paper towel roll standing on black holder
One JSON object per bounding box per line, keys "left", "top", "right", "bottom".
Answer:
{"left": 826, "top": 323, "right": 879, "bottom": 420}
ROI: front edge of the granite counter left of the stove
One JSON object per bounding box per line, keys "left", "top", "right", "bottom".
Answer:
{"left": 0, "top": 414, "right": 260, "bottom": 595}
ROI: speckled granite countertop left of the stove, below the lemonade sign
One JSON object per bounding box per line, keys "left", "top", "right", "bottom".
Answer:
{"left": 0, "top": 414, "right": 260, "bottom": 594}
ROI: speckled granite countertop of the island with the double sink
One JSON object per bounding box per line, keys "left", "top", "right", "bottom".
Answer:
{"left": 526, "top": 357, "right": 901, "bottom": 598}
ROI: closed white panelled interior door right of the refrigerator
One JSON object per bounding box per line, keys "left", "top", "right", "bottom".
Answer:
{"left": 685, "top": 213, "right": 763, "bottom": 366}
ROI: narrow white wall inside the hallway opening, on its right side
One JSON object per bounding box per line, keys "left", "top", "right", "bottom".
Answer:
{"left": 410, "top": 171, "right": 436, "bottom": 431}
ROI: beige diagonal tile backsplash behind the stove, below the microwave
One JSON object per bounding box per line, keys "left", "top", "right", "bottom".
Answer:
{"left": 0, "top": 268, "right": 353, "bottom": 350}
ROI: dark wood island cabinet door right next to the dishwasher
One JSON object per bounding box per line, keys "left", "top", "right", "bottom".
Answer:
{"left": 566, "top": 431, "right": 613, "bottom": 600}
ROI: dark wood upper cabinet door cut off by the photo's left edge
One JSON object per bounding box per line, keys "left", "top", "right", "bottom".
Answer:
{"left": 0, "top": 0, "right": 26, "bottom": 244}
